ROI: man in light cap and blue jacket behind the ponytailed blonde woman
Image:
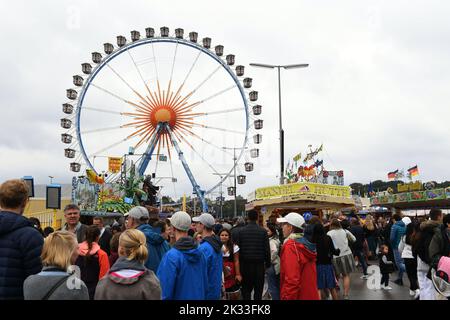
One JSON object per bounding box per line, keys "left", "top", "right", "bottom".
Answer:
{"left": 125, "top": 207, "right": 170, "bottom": 273}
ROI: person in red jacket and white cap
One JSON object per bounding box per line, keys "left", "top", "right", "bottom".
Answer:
{"left": 278, "top": 212, "right": 320, "bottom": 300}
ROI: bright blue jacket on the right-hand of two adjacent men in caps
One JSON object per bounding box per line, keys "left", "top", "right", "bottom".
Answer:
{"left": 199, "top": 236, "right": 223, "bottom": 300}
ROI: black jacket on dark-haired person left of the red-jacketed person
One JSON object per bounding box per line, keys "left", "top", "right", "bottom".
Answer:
{"left": 236, "top": 221, "right": 271, "bottom": 267}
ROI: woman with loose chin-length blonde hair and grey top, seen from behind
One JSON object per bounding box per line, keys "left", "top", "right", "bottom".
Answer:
{"left": 23, "top": 231, "right": 89, "bottom": 300}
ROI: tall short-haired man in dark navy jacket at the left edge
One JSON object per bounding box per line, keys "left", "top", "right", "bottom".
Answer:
{"left": 0, "top": 180, "right": 44, "bottom": 300}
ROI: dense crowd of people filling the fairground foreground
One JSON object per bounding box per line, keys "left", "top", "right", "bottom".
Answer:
{"left": 0, "top": 180, "right": 450, "bottom": 300}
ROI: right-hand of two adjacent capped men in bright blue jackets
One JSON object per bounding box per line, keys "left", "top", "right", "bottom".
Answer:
{"left": 192, "top": 213, "right": 223, "bottom": 300}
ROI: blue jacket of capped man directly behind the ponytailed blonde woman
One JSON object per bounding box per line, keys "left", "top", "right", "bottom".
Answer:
{"left": 136, "top": 224, "right": 170, "bottom": 273}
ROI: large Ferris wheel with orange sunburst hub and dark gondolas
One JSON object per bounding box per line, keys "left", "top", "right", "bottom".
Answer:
{"left": 61, "top": 27, "right": 263, "bottom": 210}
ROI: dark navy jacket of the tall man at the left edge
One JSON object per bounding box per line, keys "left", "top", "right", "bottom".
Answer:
{"left": 0, "top": 211, "right": 44, "bottom": 300}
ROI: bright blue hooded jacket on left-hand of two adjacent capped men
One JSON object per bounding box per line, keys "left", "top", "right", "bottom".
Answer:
{"left": 157, "top": 237, "right": 208, "bottom": 300}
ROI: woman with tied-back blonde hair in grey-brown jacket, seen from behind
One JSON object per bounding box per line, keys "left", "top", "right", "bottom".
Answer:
{"left": 95, "top": 229, "right": 161, "bottom": 300}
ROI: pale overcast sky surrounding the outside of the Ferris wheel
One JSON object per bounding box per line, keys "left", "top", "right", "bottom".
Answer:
{"left": 0, "top": 0, "right": 450, "bottom": 200}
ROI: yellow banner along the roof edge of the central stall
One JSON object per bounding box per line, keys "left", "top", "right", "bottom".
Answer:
{"left": 256, "top": 183, "right": 351, "bottom": 200}
